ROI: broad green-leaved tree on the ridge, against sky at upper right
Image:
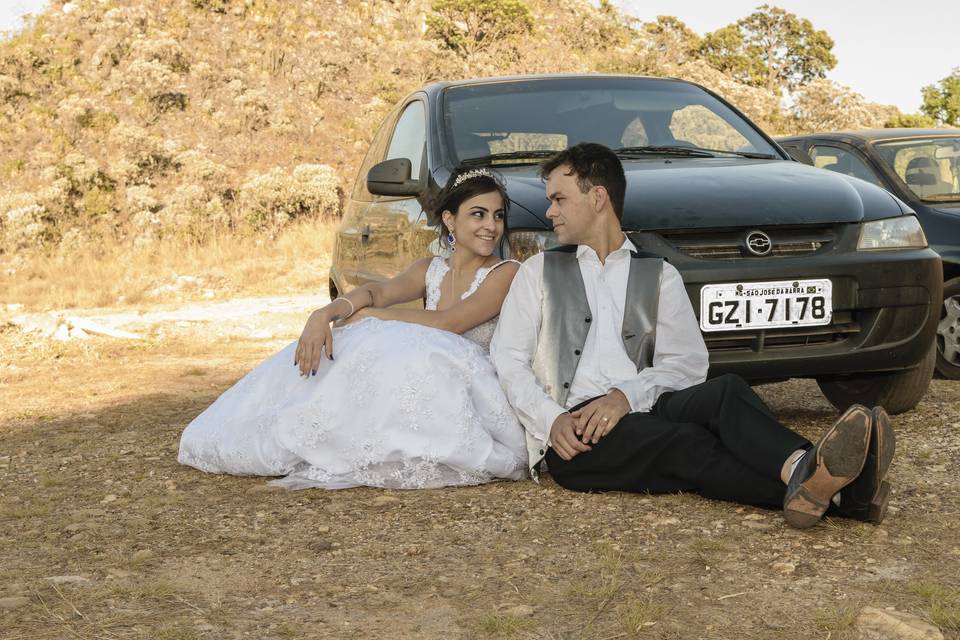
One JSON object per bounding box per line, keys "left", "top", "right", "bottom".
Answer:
{"left": 700, "top": 4, "right": 837, "bottom": 95}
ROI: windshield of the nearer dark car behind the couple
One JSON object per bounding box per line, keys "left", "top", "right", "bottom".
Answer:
{"left": 442, "top": 77, "right": 782, "bottom": 165}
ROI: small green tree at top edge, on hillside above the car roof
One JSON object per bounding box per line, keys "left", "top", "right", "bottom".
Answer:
{"left": 427, "top": 0, "right": 533, "bottom": 57}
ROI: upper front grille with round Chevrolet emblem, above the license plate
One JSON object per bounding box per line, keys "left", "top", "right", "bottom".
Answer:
{"left": 660, "top": 227, "right": 836, "bottom": 260}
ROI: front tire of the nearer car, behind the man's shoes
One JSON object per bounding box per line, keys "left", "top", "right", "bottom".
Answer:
{"left": 817, "top": 345, "right": 937, "bottom": 414}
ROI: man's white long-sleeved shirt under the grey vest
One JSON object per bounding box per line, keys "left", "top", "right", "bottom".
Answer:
{"left": 490, "top": 237, "right": 709, "bottom": 457}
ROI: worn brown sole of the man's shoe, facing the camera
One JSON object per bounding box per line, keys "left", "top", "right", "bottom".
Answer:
{"left": 783, "top": 405, "right": 871, "bottom": 529}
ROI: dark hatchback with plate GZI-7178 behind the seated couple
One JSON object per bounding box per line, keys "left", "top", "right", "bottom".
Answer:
{"left": 330, "top": 75, "right": 942, "bottom": 413}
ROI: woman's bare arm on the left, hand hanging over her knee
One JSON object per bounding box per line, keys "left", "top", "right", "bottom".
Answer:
{"left": 293, "top": 258, "right": 430, "bottom": 376}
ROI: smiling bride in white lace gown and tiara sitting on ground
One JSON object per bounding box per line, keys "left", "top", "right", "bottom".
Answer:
{"left": 178, "top": 168, "right": 527, "bottom": 489}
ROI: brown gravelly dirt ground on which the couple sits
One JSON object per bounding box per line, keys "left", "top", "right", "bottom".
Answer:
{"left": 0, "top": 302, "right": 960, "bottom": 640}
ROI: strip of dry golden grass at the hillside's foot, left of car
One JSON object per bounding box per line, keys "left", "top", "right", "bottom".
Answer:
{"left": 0, "top": 220, "right": 337, "bottom": 311}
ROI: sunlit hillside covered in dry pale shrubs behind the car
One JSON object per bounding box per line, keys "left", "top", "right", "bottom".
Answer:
{"left": 0, "top": 0, "right": 912, "bottom": 262}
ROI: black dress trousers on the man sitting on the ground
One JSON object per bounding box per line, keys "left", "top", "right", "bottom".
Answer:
{"left": 546, "top": 375, "right": 810, "bottom": 508}
